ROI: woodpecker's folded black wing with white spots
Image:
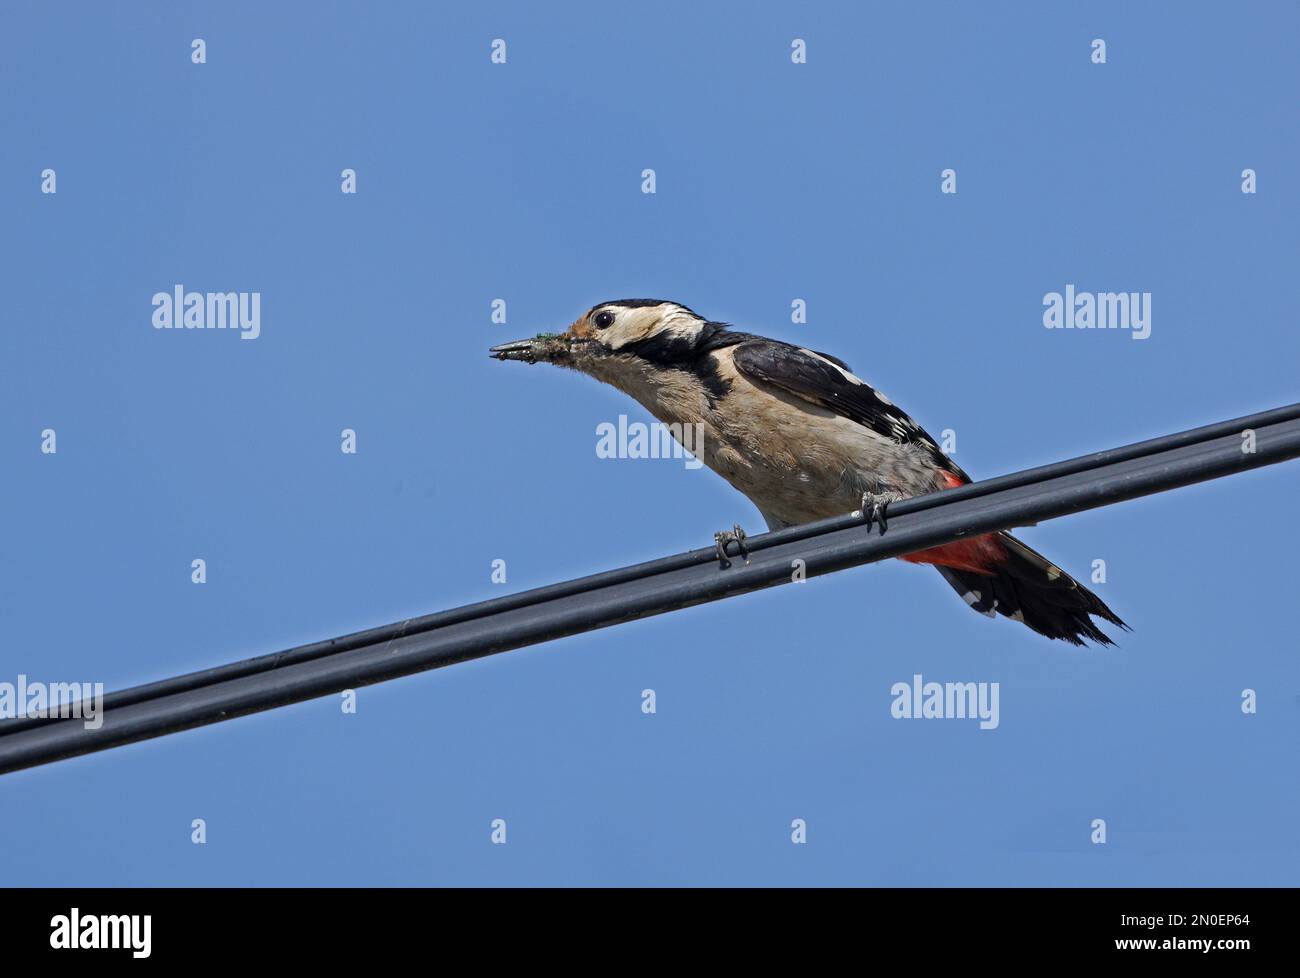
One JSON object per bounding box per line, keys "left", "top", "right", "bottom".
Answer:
{"left": 732, "top": 337, "right": 970, "bottom": 482}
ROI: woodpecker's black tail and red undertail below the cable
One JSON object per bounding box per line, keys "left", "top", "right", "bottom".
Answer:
{"left": 902, "top": 533, "right": 1128, "bottom": 645}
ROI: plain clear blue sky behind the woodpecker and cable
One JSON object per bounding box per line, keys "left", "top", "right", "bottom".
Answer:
{"left": 0, "top": 3, "right": 1300, "bottom": 886}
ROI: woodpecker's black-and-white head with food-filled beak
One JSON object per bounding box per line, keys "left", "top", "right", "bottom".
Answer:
{"left": 489, "top": 299, "right": 710, "bottom": 376}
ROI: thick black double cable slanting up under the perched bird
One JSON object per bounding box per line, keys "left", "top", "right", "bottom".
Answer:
{"left": 0, "top": 404, "right": 1300, "bottom": 774}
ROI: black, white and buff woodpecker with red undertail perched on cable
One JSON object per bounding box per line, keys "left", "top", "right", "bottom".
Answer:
{"left": 489, "top": 299, "right": 1128, "bottom": 645}
